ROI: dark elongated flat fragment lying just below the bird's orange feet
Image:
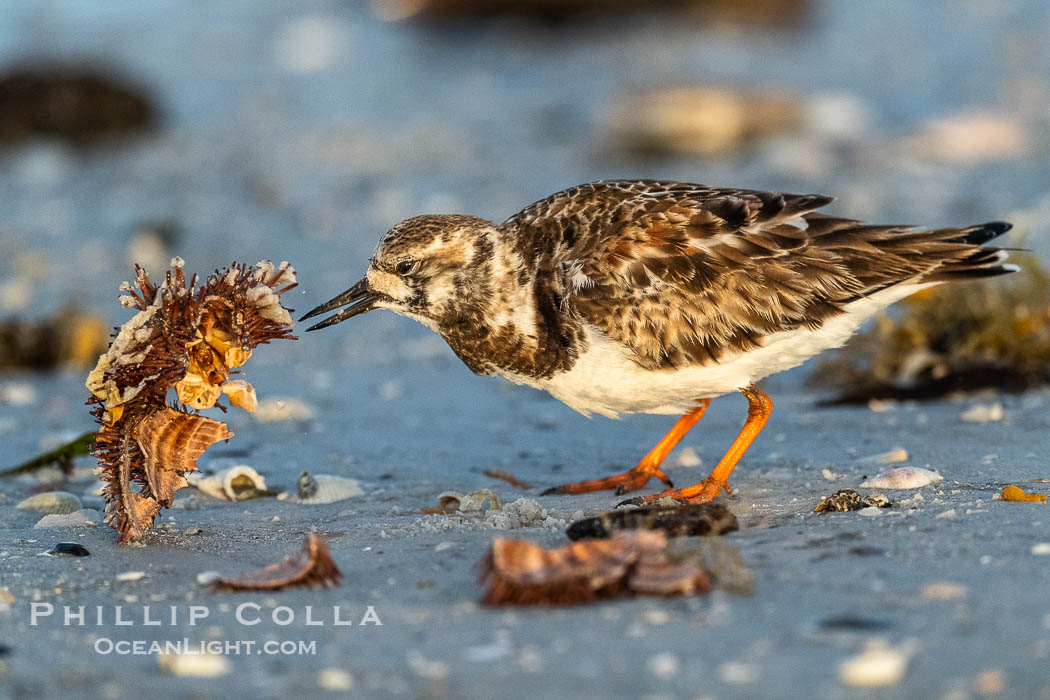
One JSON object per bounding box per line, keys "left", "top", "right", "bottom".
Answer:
{"left": 565, "top": 503, "right": 740, "bottom": 540}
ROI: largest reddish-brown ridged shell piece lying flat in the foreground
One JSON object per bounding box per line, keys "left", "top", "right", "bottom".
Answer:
{"left": 479, "top": 531, "right": 711, "bottom": 606}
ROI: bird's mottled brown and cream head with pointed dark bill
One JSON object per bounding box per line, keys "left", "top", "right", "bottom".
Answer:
{"left": 299, "top": 214, "right": 496, "bottom": 331}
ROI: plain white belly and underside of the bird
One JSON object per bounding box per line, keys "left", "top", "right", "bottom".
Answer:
{"left": 499, "top": 284, "right": 931, "bottom": 418}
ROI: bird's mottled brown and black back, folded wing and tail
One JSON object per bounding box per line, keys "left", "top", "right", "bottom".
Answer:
{"left": 503, "top": 181, "right": 1009, "bottom": 367}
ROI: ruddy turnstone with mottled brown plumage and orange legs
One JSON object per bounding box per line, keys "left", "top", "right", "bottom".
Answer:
{"left": 302, "top": 181, "right": 1016, "bottom": 503}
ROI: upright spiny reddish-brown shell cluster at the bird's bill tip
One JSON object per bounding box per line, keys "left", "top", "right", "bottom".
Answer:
{"left": 86, "top": 258, "right": 296, "bottom": 543}
